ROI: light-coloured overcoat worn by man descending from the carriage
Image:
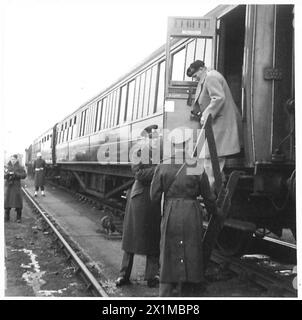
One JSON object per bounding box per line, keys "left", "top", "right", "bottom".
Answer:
{"left": 194, "top": 70, "right": 242, "bottom": 158}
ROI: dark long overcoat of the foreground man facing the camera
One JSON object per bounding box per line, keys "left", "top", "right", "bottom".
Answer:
{"left": 122, "top": 147, "right": 161, "bottom": 256}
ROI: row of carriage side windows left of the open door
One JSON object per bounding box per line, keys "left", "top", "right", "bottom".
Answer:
{"left": 57, "top": 61, "right": 165, "bottom": 143}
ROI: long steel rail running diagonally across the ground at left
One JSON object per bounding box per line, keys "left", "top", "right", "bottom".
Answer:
{"left": 22, "top": 187, "right": 108, "bottom": 297}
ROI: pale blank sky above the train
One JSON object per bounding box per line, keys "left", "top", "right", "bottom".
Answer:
{"left": 0, "top": 0, "right": 300, "bottom": 160}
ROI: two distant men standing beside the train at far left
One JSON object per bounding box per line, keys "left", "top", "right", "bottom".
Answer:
{"left": 4, "top": 152, "right": 46, "bottom": 223}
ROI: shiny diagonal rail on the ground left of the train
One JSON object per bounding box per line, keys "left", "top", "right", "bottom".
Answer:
{"left": 22, "top": 187, "right": 108, "bottom": 297}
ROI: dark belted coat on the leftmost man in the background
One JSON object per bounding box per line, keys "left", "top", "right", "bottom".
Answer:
{"left": 4, "top": 161, "right": 26, "bottom": 209}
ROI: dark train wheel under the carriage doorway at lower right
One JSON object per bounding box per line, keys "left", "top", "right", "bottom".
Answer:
{"left": 216, "top": 227, "right": 253, "bottom": 256}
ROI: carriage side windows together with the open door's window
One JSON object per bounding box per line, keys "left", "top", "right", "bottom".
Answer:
{"left": 57, "top": 38, "right": 212, "bottom": 143}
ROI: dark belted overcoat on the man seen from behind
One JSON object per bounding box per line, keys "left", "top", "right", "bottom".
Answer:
{"left": 150, "top": 158, "right": 216, "bottom": 283}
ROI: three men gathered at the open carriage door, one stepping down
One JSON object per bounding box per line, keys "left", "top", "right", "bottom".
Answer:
{"left": 116, "top": 60, "right": 241, "bottom": 297}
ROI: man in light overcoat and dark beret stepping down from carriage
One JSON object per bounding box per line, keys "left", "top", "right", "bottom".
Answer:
{"left": 187, "top": 60, "right": 242, "bottom": 186}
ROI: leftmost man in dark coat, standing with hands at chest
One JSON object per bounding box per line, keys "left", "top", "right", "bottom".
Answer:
{"left": 4, "top": 155, "right": 26, "bottom": 223}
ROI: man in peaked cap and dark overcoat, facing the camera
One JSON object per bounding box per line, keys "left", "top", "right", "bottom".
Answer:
{"left": 116, "top": 127, "right": 161, "bottom": 287}
